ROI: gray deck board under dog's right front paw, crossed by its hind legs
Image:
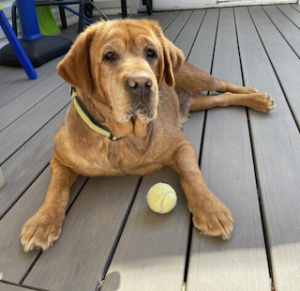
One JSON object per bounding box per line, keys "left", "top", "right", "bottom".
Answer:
{"left": 187, "top": 8, "right": 270, "bottom": 291}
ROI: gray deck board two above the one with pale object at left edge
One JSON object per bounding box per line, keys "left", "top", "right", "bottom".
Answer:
{"left": 0, "top": 73, "right": 63, "bottom": 131}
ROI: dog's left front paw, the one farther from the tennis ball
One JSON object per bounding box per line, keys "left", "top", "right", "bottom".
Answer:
{"left": 20, "top": 212, "right": 62, "bottom": 252}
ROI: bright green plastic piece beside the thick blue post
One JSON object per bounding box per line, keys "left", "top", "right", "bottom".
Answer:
{"left": 36, "top": 6, "right": 60, "bottom": 35}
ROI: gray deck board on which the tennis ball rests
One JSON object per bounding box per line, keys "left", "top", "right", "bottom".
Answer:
{"left": 101, "top": 11, "right": 204, "bottom": 291}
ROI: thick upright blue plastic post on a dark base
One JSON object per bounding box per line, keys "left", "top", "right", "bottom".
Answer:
{"left": 17, "top": 0, "right": 42, "bottom": 40}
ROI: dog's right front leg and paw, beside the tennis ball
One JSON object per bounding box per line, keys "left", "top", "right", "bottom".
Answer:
{"left": 170, "top": 139, "right": 233, "bottom": 239}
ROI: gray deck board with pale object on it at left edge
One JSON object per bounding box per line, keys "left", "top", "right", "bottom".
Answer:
{"left": 0, "top": 110, "right": 65, "bottom": 217}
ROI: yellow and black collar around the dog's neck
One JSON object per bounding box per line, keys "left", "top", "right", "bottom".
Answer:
{"left": 70, "top": 86, "right": 120, "bottom": 141}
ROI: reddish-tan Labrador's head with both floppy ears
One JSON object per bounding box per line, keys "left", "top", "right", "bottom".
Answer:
{"left": 57, "top": 19, "right": 184, "bottom": 123}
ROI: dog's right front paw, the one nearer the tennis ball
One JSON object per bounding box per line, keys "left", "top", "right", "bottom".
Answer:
{"left": 190, "top": 194, "right": 233, "bottom": 240}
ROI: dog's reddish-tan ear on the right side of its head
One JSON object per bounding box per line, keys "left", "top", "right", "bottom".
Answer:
{"left": 148, "top": 21, "right": 184, "bottom": 87}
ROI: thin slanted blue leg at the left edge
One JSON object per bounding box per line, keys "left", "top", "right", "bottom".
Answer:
{"left": 0, "top": 6, "right": 37, "bottom": 79}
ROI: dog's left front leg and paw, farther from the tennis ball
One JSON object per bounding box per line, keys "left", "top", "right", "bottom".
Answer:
{"left": 20, "top": 156, "right": 77, "bottom": 252}
